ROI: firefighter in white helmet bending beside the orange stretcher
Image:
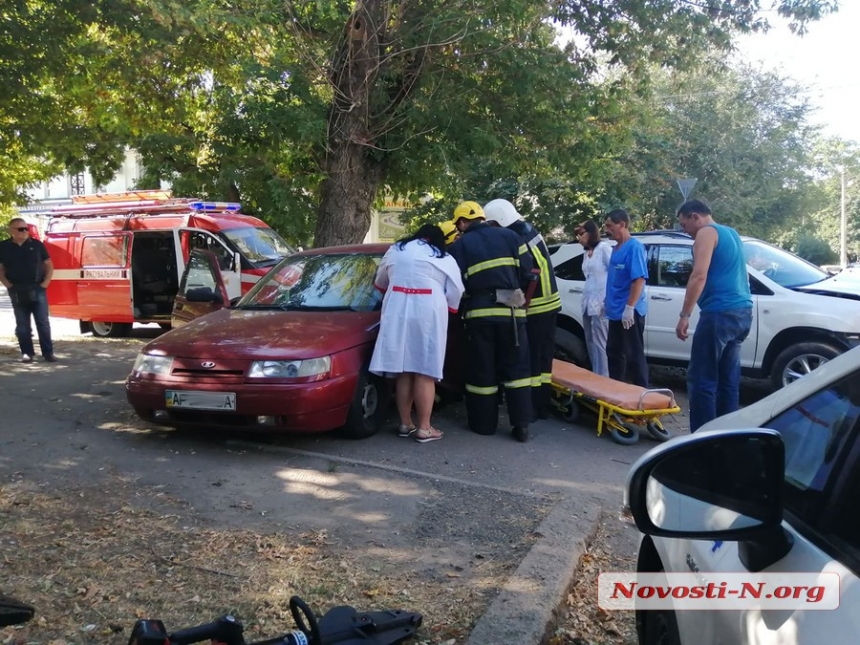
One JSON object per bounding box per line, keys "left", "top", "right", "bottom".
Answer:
{"left": 484, "top": 199, "right": 561, "bottom": 419}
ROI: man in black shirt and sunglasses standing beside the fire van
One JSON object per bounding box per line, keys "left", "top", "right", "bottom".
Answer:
{"left": 0, "top": 217, "right": 57, "bottom": 363}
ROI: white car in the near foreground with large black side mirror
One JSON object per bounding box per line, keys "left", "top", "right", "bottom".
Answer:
{"left": 626, "top": 348, "right": 860, "bottom": 645}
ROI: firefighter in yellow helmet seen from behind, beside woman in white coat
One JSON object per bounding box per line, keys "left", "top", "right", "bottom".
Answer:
{"left": 448, "top": 202, "right": 533, "bottom": 442}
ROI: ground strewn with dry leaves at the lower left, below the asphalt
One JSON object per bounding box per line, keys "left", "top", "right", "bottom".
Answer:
{"left": 0, "top": 480, "right": 536, "bottom": 645}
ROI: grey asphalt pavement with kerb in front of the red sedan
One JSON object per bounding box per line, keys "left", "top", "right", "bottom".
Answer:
{"left": 0, "top": 290, "right": 768, "bottom": 644}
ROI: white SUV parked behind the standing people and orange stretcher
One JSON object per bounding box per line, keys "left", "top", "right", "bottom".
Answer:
{"left": 552, "top": 231, "right": 860, "bottom": 388}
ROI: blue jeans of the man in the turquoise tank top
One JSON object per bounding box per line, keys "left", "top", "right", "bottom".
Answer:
{"left": 687, "top": 308, "right": 752, "bottom": 432}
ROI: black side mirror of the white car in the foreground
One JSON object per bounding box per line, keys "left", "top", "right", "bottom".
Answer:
{"left": 626, "top": 428, "right": 792, "bottom": 570}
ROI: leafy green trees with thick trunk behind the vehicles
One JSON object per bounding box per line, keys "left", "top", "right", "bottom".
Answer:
{"left": 0, "top": 0, "right": 835, "bottom": 245}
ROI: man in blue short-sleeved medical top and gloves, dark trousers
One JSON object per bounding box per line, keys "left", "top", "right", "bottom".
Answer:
{"left": 603, "top": 208, "right": 648, "bottom": 387}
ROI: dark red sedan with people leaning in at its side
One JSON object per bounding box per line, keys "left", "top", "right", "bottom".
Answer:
{"left": 126, "top": 244, "right": 463, "bottom": 439}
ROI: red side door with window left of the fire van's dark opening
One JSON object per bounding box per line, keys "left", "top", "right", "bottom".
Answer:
{"left": 77, "top": 231, "right": 134, "bottom": 326}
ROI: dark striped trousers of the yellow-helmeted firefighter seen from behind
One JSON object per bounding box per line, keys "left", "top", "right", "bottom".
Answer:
{"left": 466, "top": 318, "right": 532, "bottom": 434}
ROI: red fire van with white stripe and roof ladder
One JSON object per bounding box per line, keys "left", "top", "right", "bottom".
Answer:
{"left": 42, "top": 191, "right": 294, "bottom": 337}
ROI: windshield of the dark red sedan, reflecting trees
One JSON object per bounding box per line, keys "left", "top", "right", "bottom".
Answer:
{"left": 236, "top": 253, "right": 382, "bottom": 311}
